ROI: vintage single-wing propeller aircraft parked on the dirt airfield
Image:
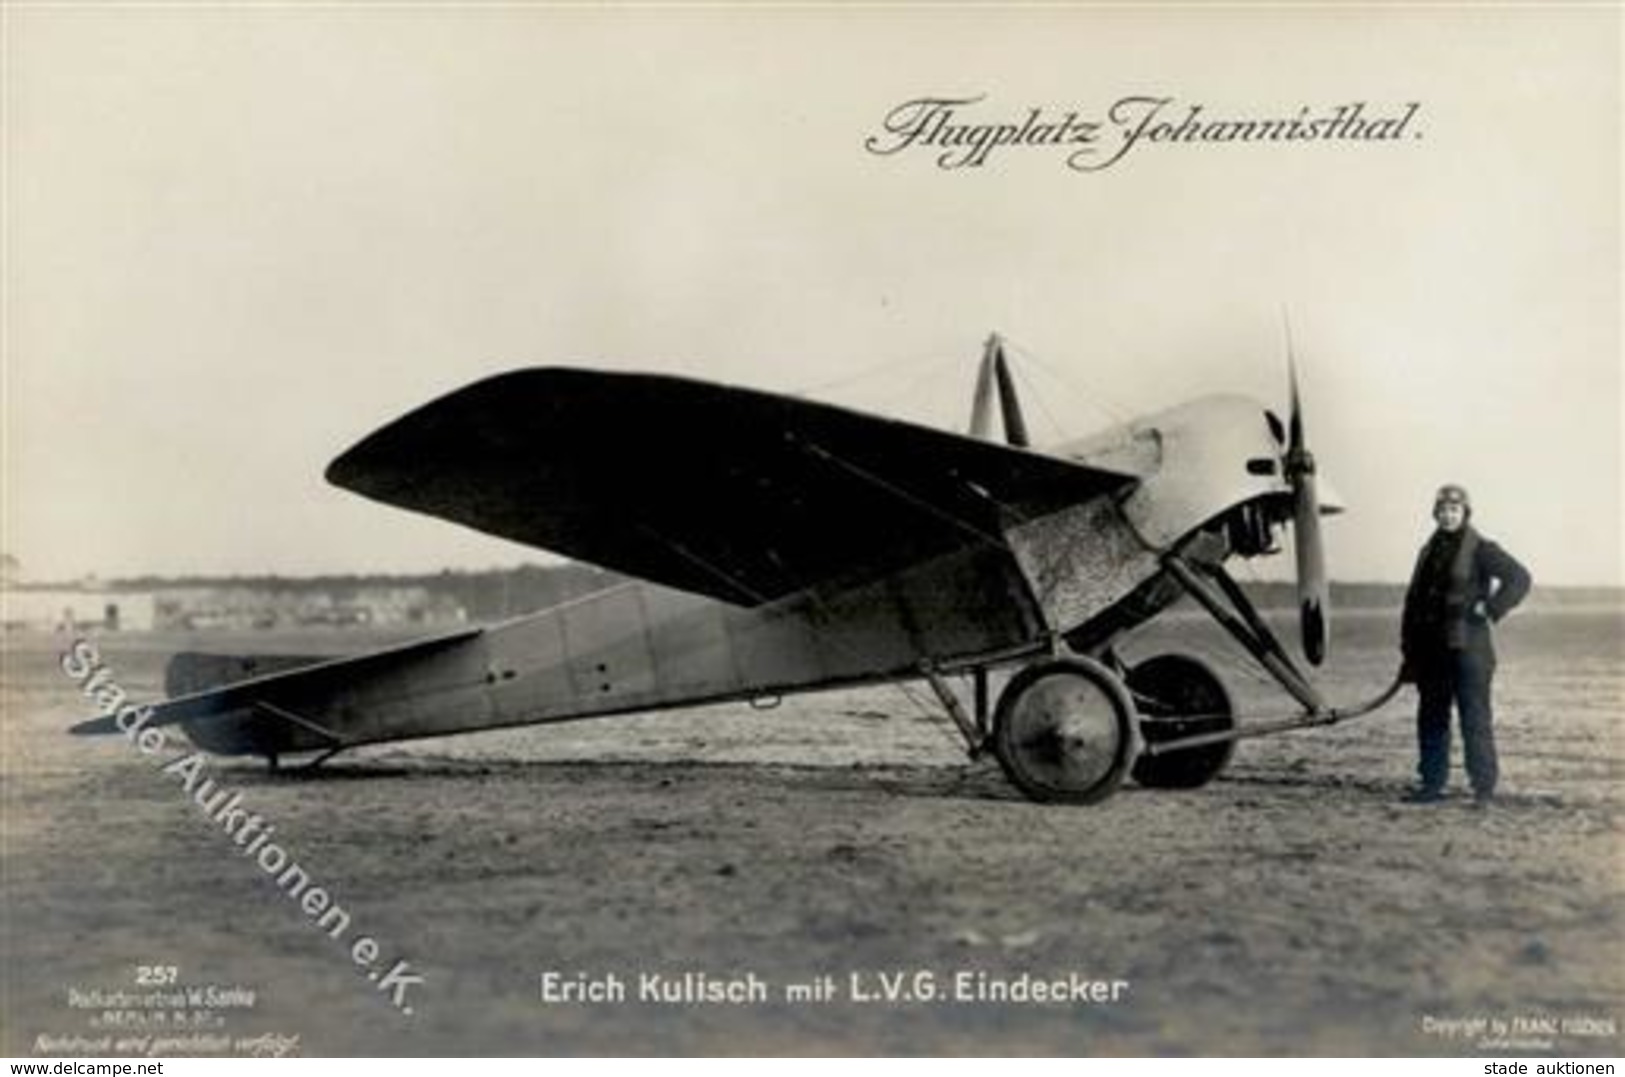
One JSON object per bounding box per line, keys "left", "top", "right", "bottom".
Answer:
{"left": 75, "top": 336, "right": 1397, "bottom": 802}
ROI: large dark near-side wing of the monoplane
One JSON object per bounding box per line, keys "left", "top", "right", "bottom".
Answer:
{"left": 327, "top": 367, "right": 1134, "bottom": 606}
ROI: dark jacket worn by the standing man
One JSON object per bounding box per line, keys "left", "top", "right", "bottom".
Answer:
{"left": 1399, "top": 526, "right": 1529, "bottom": 671}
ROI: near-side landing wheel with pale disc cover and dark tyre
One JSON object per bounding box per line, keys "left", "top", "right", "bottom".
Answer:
{"left": 993, "top": 658, "right": 1134, "bottom": 804}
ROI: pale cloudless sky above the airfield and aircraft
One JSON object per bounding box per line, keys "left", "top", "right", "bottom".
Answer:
{"left": 0, "top": 3, "right": 1625, "bottom": 585}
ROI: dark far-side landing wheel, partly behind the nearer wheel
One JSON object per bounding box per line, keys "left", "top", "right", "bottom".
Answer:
{"left": 1125, "top": 655, "right": 1235, "bottom": 789}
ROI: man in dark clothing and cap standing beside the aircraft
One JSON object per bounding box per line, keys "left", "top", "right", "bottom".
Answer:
{"left": 1401, "top": 486, "right": 1529, "bottom": 807}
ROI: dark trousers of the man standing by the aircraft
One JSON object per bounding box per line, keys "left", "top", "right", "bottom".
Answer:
{"left": 1417, "top": 650, "right": 1497, "bottom": 796}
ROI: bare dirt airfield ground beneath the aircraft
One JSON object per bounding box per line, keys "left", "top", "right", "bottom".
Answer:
{"left": 0, "top": 609, "right": 1625, "bottom": 1056}
